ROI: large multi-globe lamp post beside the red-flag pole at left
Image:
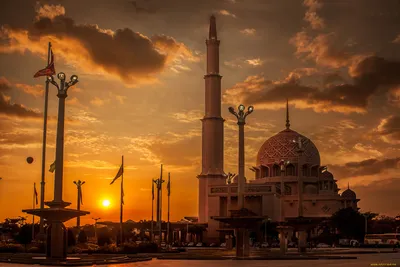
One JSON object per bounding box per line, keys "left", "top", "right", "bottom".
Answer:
{"left": 47, "top": 72, "right": 78, "bottom": 204}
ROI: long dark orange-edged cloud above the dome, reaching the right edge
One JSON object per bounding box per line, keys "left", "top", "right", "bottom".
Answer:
{"left": 225, "top": 56, "right": 400, "bottom": 112}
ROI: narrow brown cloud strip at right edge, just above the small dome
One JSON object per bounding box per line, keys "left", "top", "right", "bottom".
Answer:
{"left": 328, "top": 157, "right": 400, "bottom": 179}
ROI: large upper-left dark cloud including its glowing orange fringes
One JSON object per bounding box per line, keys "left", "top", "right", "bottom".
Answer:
{"left": 3, "top": 5, "right": 196, "bottom": 83}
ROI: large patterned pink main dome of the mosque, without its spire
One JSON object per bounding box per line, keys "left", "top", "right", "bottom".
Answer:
{"left": 257, "top": 129, "right": 321, "bottom": 166}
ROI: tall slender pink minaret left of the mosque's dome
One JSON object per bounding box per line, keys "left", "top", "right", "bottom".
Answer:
{"left": 198, "top": 16, "right": 225, "bottom": 222}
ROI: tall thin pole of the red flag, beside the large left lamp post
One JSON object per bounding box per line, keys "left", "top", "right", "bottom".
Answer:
{"left": 39, "top": 42, "right": 51, "bottom": 235}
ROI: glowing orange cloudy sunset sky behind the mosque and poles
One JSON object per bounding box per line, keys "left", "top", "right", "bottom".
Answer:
{"left": 0, "top": 0, "right": 400, "bottom": 224}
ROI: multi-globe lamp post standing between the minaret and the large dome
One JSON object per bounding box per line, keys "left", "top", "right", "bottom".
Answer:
{"left": 228, "top": 104, "right": 254, "bottom": 209}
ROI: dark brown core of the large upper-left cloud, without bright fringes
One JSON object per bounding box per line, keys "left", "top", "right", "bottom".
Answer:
{"left": 30, "top": 16, "right": 166, "bottom": 79}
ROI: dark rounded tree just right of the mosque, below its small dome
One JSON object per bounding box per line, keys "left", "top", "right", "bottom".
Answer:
{"left": 331, "top": 208, "right": 365, "bottom": 240}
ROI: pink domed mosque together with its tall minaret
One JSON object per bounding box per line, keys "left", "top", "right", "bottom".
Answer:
{"left": 197, "top": 16, "right": 359, "bottom": 243}
